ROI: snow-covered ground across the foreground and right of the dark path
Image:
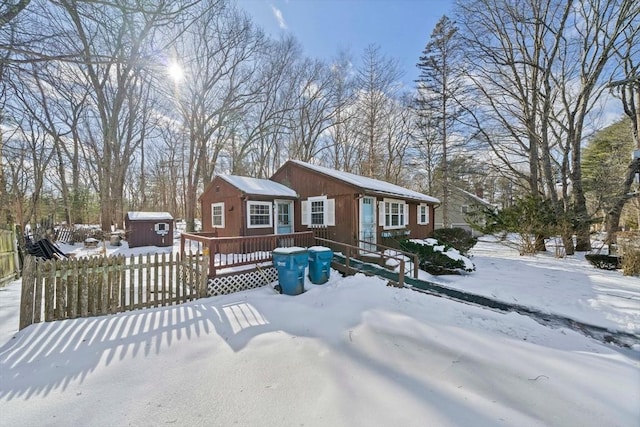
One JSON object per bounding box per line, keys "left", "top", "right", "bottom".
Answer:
{"left": 0, "top": 241, "right": 640, "bottom": 426}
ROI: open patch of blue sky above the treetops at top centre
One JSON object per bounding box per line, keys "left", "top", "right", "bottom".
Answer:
{"left": 237, "top": 0, "right": 453, "bottom": 86}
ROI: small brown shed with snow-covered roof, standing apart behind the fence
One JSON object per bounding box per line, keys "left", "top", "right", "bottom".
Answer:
{"left": 124, "top": 212, "right": 174, "bottom": 248}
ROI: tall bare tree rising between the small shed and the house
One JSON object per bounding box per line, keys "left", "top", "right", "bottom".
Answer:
{"left": 170, "top": 5, "right": 264, "bottom": 230}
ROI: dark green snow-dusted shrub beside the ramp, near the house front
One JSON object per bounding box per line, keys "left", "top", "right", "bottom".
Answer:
{"left": 400, "top": 239, "right": 476, "bottom": 274}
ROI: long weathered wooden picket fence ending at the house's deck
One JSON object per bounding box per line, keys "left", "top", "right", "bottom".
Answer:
{"left": 19, "top": 253, "right": 208, "bottom": 329}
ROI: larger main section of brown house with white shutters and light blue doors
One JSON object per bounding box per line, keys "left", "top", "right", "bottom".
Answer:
{"left": 271, "top": 160, "right": 440, "bottom": 249}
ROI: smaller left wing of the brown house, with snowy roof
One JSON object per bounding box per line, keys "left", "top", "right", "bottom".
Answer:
{"left": 199, "top": 175, "right": 298, "bottom": 237}
